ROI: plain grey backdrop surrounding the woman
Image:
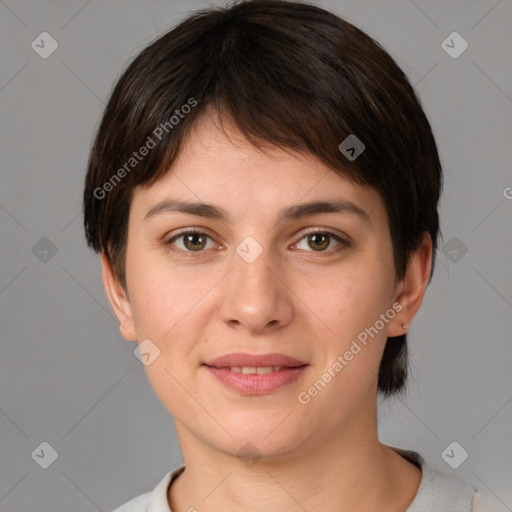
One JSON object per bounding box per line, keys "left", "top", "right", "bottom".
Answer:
{"left": 0, "top": 0, "right": 512, "bottom": 512}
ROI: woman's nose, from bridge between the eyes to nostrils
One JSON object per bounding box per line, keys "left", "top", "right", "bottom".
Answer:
{"left": 220, "top": 241, "right": 293, "bottom": 334}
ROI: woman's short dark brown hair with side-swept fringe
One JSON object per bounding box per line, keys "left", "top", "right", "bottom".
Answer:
{"left": 83, "top": 0, "right": 442, "bottom": 395}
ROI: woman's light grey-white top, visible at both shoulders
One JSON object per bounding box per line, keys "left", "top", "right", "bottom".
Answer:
{"left": 113, "top": 448, "right": 492, "bottom": 512}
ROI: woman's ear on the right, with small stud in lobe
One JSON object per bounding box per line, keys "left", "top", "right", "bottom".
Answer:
{"left": 388, "top": 232, "right": 432, "bottom": 337}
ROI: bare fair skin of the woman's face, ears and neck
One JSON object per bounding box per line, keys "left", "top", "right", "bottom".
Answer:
{"left": 102, "top": 112, "right": 432, "bottom": 512}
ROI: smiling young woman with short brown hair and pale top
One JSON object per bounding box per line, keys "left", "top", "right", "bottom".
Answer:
{"left": 84, "top": 0, "right": 484, "bottom": 512}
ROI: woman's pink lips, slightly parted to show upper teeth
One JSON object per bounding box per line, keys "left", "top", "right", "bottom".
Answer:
{"left": 203, "top": 353, "right": 308, "bottom": 395}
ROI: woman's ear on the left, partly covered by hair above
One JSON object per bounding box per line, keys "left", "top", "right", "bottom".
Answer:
{"left": 101, "top": 252, "right": 137, "bottom": 341}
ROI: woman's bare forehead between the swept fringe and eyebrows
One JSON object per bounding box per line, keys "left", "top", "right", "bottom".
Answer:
{"left": 132, "top": 115, "right": 385, "bottom": 226}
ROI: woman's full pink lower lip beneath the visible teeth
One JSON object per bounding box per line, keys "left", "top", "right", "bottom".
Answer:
{"left": 205, "top": 365, "right": 307, "bottom": 395}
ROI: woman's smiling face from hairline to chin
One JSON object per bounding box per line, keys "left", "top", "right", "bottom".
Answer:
{"left": 104, "top": 117, "right": 424, "bottom": 457}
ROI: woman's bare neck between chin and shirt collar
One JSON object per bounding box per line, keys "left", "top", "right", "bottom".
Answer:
{"left": 168, "top": 398, "right": 421, "bottom": 512}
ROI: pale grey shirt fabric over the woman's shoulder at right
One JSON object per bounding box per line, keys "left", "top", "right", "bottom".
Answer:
{"left": 394, "top": 448, "right": 477, "bottom": 512}
